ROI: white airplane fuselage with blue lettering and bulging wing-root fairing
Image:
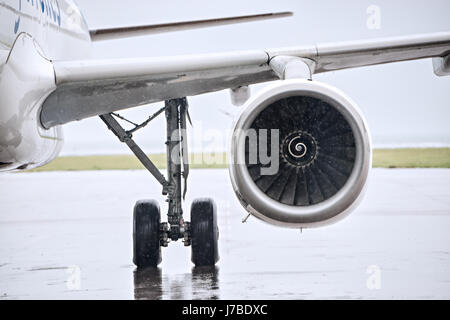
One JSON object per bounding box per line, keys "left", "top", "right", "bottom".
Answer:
{"left": 0, "top": 0, "right": 91, "bottom": 171}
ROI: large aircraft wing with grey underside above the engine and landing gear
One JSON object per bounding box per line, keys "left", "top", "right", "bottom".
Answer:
{"left": 41, "top": 32, "right": 450, "bottom": 128}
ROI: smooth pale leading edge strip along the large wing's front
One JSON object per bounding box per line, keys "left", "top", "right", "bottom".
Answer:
{"left": 53, "top": 32, "right": 450, "bottom": 84}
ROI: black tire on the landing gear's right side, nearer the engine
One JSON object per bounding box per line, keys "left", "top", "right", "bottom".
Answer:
{"left": 191, "top": 198, "right": 219, "bottom": 267}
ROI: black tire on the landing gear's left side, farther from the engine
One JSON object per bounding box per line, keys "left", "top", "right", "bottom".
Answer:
{"left": 133, "top": 200, "right": 161, "bottom": 268}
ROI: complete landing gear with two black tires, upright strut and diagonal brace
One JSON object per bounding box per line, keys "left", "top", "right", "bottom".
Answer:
{"left": 100, "top": 98, "right": 219, "bottom": 267}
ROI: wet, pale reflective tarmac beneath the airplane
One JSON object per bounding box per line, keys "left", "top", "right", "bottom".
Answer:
{"left": 0, "top": 169, "right": 450, "bottom": 299}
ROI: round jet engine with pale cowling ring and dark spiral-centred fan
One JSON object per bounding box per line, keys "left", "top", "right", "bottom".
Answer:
{"left": 229, "top": 80, "right": 372, "bottom": 228}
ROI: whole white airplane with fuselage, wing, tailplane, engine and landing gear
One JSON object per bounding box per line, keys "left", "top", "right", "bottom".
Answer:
{"left": 0, "top": 0, "right": 450, "bottom": 268}
